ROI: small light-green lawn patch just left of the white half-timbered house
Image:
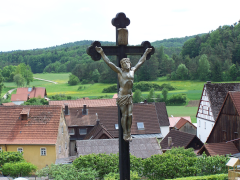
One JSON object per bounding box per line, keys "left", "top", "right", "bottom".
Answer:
{"left": 167, "top": 106, "right": 198, "bottom": 123}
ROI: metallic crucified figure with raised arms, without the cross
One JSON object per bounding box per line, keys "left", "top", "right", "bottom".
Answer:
{"left": 95, "top": 46, "right": 152, "bottom": 141}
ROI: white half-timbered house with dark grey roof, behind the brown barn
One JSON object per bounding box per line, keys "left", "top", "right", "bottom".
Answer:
{"left": 196, "top": 81, "right": 240, "bottom": 143}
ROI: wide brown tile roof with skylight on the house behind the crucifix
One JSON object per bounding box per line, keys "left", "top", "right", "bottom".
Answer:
{"left": 65, "top": 104, "right": 160, "bottom": 137}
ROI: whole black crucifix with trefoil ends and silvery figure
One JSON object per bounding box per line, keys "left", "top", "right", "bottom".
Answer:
{"left": 87, "top": 13, "right": 155, "bottom": 180}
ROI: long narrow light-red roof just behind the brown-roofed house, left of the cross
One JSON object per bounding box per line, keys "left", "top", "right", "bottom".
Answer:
{"left": 49, "top": 99, "right": 117, "bottom": 108}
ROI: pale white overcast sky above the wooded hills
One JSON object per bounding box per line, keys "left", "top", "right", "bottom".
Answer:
{"left": 0, "top": 0, "right": 240, "bottom": 51}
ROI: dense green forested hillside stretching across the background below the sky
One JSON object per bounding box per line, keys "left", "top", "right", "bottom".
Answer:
{"left": 0, "top": 21, "right": 240, "bottom": 83}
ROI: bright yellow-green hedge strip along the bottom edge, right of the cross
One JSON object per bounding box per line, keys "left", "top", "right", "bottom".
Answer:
{"left": 166, "top": 174, "right": 228, "bottom": 180}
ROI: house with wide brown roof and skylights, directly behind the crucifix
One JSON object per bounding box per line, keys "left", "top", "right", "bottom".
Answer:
{"left": 62, "top": 103, "right": 169, "bottom": 155}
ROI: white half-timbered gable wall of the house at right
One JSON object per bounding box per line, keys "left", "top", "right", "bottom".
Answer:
{"left": 197, "top": 86, "right": 215, "bottom": 143}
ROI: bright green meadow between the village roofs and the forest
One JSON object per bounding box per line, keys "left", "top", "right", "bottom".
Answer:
{"left": 2, "top": 73, "right": 205, "bottom": 122}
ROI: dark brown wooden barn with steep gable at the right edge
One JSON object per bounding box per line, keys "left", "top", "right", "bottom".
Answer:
{"left": 206, "top": 91, "right": 240, "bottom": 151}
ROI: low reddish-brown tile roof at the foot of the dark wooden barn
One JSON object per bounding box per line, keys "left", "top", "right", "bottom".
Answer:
{"left": 198, "top": 142, "right": 239, "bottom": 156}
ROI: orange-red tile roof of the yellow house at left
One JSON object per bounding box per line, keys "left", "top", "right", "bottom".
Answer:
{"left": 0, "top": 106, "right": 62, "bottom": 144}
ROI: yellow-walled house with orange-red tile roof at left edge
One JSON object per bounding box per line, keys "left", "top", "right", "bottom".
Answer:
{"left": 0, "top": 106, "right": 69, "bottom": 169}
